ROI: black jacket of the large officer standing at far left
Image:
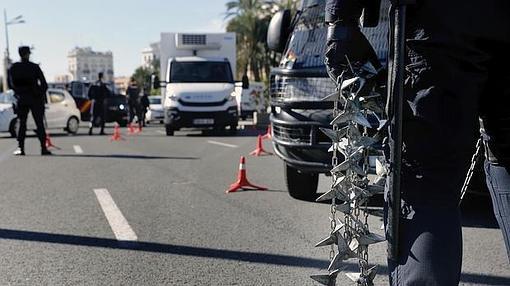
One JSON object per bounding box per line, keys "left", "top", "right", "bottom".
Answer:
{"left": 8, "top": 61, "right": 48, "bottom": 105}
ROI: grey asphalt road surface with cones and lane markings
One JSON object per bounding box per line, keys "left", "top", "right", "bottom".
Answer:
{"left": 0, "top": 127, "right": 510, "bottom": 285}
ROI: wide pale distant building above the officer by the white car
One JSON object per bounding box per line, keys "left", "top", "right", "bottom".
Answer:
{"left": 67, "top": 47, "right": 114, "bottom": 82}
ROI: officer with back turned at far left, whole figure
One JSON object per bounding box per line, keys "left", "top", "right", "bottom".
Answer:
{"left": 8, "top": 46, "right": 51, "bottom": 156}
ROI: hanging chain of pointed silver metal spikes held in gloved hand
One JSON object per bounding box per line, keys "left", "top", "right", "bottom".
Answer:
{"left": 311, "top": 63, "right": 385, "bottom": 286}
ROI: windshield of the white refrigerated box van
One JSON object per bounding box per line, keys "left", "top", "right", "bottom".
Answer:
{"left": 169, "top": 62, "right": 234, "bottom": 83}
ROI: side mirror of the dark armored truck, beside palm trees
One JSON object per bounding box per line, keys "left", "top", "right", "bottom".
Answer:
{"left": 267, "top": 9, "right": 292, "bottom": 53}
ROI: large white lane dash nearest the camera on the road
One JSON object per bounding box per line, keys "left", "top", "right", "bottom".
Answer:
{"left": 94, "top": 189, "right": 138, "bottom": 241}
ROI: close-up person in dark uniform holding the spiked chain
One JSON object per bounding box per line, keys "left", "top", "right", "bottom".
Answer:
{"left": 325, "top": 0, "right": 510, "bottom": 285}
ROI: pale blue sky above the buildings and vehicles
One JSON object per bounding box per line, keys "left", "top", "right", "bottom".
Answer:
{"left": 0, "top": 0, "right": 228, "bottom": 81}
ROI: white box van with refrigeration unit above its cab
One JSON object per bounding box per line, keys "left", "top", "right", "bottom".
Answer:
{"left": 155, "top": 33, "right": 238, "bottom": 136}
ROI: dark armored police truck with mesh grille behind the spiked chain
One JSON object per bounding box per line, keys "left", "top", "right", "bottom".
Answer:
{"left": 268, "top": 0, "right": 389, "bottom": 200}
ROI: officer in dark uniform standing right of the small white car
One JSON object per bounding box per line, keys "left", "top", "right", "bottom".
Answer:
{"left": 88, "top": 72, "right": 110, "bottom": 135}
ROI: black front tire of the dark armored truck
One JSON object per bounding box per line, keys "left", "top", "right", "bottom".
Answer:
{"left": 284, "top": 163, "right": 319, "bottom": 201}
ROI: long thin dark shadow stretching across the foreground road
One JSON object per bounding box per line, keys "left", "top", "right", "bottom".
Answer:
{"left": 0, "top": 229, "right": 510, "bottom": 285}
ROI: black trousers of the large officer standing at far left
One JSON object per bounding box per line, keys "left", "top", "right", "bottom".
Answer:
{"left": 17, "top": 103, "right": 46, "bottom": 149}
